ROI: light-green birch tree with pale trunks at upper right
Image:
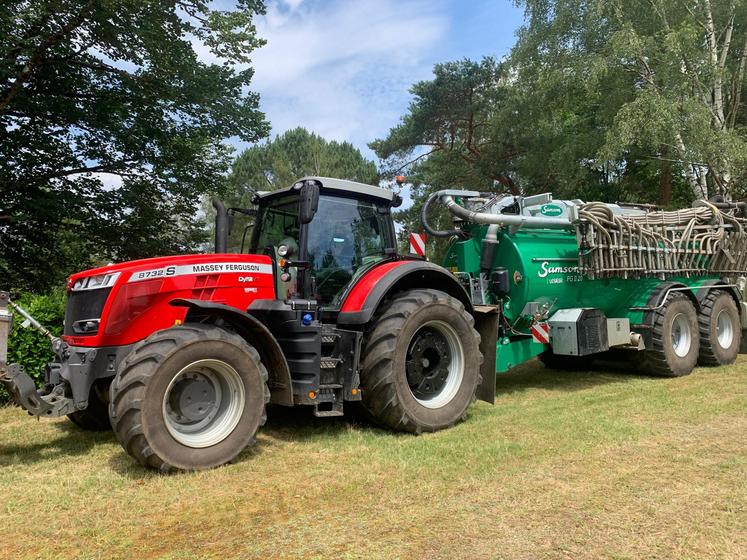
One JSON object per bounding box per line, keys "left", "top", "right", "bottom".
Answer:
{"left": 511, "top": 0, "right": 747, "bottom": 203}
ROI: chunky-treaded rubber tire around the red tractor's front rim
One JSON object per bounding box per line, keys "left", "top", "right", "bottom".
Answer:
{"left": 109, "top": 324, "right": 270, "bottom": 472}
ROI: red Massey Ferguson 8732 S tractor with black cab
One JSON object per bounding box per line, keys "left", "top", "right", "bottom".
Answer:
{"left": 0, "top": 177, "right": 495, "bottom": 471}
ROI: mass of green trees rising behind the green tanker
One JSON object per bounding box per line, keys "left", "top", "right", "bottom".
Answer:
{"left": 370, "top": 0, "right": 747, "bottom": 238}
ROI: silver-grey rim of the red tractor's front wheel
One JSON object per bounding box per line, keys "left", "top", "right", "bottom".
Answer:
{"left": 163, "top": 360, "right": 246, "bottom": 448}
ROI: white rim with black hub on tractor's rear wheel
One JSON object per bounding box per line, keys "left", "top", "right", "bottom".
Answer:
{"left": 405, "top": 321, "right": 465, "bottom": 408}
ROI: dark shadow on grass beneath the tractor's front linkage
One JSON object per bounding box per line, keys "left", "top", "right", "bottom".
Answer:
{"left": 0, "top": 422, "right": 114, "bottom": 467}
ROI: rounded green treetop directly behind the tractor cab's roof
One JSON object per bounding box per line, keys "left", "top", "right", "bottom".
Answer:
{"left": 227, "top": 127, "right": 379, "bottom": 249}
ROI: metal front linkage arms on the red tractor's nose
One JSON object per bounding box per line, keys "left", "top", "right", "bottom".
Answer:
{"left": 0, "top": 292, "right": 78, "bottom": 416}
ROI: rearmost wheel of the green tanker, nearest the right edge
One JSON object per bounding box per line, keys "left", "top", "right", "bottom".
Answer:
{"left": 698, "top": 290, "right": 742, "bottom": 366}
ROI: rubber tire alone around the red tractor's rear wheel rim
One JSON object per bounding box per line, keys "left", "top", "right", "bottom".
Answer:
{"left": 361, "top": 290, "right": 482, "bottom": 434}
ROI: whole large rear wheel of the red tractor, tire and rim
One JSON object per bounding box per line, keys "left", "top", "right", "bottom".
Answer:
{"left": 361, "top": 290, "right": 482, "bottom": 433}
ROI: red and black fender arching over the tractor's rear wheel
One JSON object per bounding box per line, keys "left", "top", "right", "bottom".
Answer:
{"left": 337, "top": 260, "right": 473, "bottom": 325}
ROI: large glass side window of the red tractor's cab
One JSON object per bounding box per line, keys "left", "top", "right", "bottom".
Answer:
{"left": 308, "top": 195, "right": 389, "bottom": 304}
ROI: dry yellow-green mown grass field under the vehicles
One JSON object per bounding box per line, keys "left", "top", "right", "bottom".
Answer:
{"left": 0, "top": 356, "right": 747, "bottom": 559}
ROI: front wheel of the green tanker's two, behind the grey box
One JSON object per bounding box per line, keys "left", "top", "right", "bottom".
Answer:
{"left": 642, "top": 292, "right": 700, "bottom": 377}
